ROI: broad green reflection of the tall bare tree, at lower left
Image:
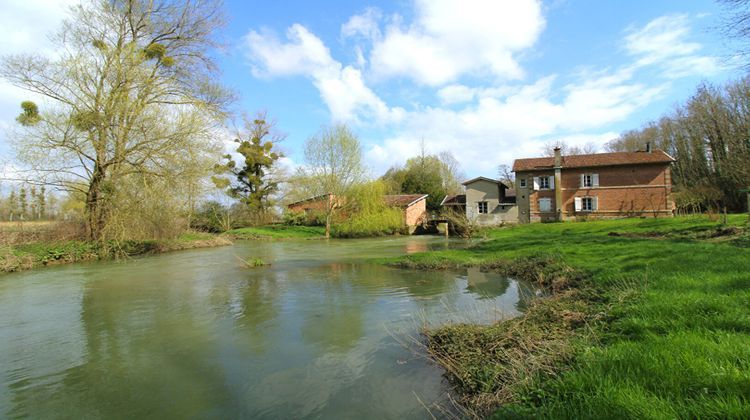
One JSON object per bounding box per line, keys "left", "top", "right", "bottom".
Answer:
{"left": 7, "top": 270, "right": 234, "bottom": 418}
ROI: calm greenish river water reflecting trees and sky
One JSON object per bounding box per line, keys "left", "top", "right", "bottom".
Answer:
{"left": 0, "top": 237, "right": 530, "bottom": 419}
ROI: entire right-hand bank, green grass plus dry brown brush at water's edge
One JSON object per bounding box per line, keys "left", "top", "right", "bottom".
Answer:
{"left": 388, "top": 215, "right": 750, "bottom": 418}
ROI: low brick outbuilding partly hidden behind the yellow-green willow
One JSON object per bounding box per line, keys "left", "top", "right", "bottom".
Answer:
{"left": 287, "top": 194, "right": 428, "bottom": 233}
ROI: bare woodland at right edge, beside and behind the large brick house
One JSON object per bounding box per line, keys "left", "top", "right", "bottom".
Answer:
{"left": 607, "top": 77, "right": 750, "bottom": 213}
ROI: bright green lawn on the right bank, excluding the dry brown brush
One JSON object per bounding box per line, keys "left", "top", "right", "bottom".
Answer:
{"left": 388, "top": 215, "right": 750, "bottom": 418}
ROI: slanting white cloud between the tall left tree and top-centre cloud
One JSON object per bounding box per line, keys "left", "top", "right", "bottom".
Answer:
{"left": 245, "top": 24, "right": 403, "bottom": 122}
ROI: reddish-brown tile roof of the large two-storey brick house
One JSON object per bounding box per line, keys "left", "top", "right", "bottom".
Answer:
{"left": 513, "top": 150, "right": 675, "bottom": 172}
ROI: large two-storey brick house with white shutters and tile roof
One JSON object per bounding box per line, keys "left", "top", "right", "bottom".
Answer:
{"left": 513, "top": 147, "right": 674, "bottom": 223}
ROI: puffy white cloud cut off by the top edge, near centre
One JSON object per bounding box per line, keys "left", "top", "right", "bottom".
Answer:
{"left": 369, "top": 0, "right": 545, "bottom": 86}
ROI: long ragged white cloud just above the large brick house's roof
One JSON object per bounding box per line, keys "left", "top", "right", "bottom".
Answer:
{"left": 367, "top": 71, "right": 664, "bottom": 176}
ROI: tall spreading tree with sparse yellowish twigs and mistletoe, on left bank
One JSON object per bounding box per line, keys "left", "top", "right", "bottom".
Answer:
{"left": 0, "top": 0, "right": 231, "bottom": 240}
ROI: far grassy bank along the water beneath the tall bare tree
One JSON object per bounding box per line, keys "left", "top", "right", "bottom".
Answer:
{"left": 0, "top": 232, "right": 231, "bottom": 273}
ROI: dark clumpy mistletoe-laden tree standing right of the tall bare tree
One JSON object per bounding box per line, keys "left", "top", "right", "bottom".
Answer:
{"left": 213, "top": 113, "right": 284, "bottom": 221}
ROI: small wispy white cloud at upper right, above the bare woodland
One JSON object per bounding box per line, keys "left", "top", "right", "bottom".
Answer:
{"left": 625, "top": 14, "right": 721, "bottom": 78}
